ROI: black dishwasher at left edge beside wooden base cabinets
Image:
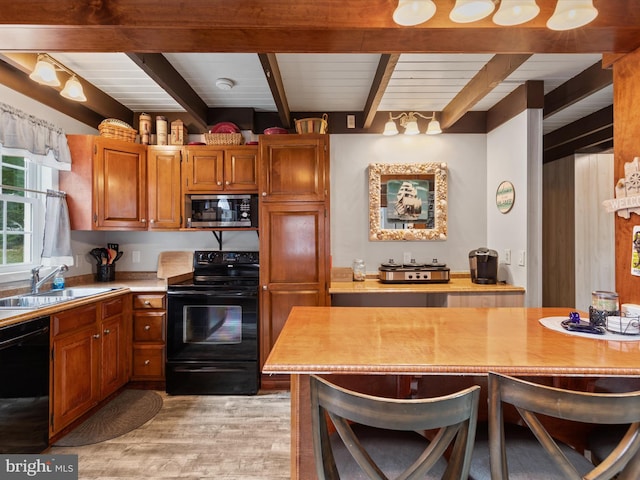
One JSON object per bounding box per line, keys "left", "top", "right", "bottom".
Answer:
{"left": 0, "top": 317, "right": 50, "bottom": 454}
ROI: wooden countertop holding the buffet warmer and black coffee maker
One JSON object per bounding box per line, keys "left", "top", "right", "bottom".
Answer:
{"left": 329, "top": 277, "right": 525, "bottom": 294}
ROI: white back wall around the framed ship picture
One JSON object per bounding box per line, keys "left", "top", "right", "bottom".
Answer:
{"left": 331, "top": 134, "right": 487, "bottom": 273}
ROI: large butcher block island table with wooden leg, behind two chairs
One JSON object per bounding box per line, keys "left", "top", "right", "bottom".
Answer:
{"left": 262, "top": 307, "right": 640, "bottom": 480}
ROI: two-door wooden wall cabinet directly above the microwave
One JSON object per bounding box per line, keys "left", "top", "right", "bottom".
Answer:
{"left": 182, "top": 145, "right": 258, "bottom": 194}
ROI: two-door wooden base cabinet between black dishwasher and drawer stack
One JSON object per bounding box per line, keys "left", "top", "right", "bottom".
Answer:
{"left": 50, "top": 295, "right": 131, "bottom": 435}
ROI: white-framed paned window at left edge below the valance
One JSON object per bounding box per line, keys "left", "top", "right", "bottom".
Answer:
{"left": 0, "top": 155, "right": 52, "bottom": 280}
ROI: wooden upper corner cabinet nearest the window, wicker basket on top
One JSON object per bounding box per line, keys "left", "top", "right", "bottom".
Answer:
{"left": 59, "top": 135, "right": 147, "bottom": 230}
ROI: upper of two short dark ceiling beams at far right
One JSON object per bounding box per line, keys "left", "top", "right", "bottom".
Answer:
{"left": 543, "top": 62, "right": 613, "bottom": 118}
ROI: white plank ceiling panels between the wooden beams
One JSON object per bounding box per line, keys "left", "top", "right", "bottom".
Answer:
{"left": 52, "top": 53, "right": 613, "bottom": 133}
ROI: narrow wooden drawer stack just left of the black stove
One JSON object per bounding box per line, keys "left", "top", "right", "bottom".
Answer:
{"left": 131, "top": 293, "right": 167, "bottom": 381}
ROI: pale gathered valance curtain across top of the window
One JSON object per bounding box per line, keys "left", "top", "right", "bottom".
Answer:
{"left": 0, "top": 102, "right": 71, "bottom": 170}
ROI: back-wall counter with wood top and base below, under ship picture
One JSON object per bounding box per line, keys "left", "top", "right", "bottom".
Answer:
{"left": 329, "top": 274, "right": 525, "bottom": 307}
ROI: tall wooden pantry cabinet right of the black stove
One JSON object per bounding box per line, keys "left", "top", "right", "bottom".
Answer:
{"left": 259, "top": 134, "right": 330, "bottom": 389}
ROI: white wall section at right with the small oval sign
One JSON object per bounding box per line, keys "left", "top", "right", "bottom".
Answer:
{"left": 486, "top": 110, "right": 542, "bottom": 306}
